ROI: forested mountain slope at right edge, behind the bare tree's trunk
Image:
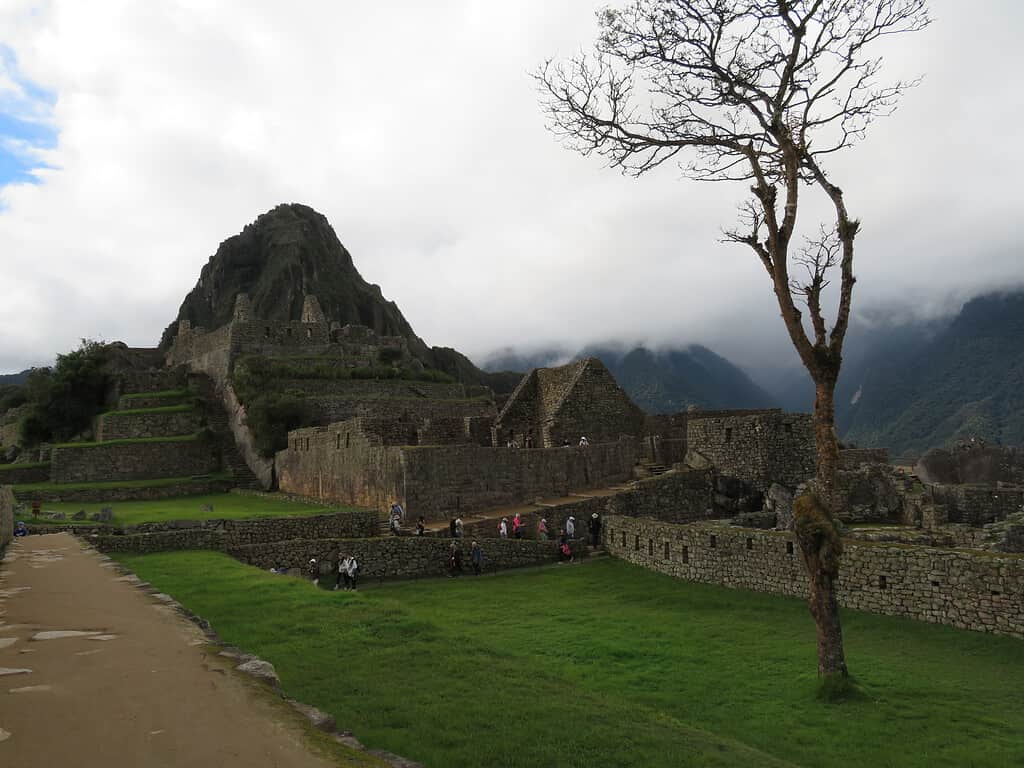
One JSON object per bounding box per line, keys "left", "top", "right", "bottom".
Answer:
{"left": 753, "top": 291, "right": 1024, "bottom": 455}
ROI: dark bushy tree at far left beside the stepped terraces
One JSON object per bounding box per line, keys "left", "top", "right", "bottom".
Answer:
{"left": 20, "top": 339, "right": 110, "bottom": 446}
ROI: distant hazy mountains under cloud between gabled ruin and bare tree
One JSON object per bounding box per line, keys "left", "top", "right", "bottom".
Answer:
{"left": 483, "top": 345, "right": 776, "bottom": 414}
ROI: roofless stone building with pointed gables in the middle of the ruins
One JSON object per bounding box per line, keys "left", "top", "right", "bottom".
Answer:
{"left": 495, "top": 357, "right": 644, "bottom": 447}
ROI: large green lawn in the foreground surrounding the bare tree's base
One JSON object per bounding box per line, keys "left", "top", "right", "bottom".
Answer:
{"left": 112, "top": 552, "right": 1024, "bottom": 768}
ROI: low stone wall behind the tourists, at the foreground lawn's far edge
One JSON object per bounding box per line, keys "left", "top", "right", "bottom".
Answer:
{"left": 228, "top": 537, "right": 558, "bottom": 581}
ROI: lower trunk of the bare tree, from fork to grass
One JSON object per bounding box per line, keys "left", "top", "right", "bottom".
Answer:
{"left": 801, "top": 375, "right": 847, "bottom": 677}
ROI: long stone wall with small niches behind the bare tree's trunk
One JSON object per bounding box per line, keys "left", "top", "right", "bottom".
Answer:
{"left": 604, "top": 516, "right": 1024, "bottom": 638}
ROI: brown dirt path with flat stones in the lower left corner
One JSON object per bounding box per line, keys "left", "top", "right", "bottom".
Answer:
{"left": 0, "top": 534, "right": 344, "bottom": 768}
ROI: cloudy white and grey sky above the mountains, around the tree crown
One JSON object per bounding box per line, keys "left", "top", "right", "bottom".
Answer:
{"left": 0, "top": 0, "right": 1024, "bottom": 372}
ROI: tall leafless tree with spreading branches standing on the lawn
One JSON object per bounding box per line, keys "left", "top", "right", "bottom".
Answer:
{"left": 535, "top": 0, "right": 930, "bottom": 675}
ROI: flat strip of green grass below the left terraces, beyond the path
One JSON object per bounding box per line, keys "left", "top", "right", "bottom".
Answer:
{"left": 23, "top": 494, "right": 346, "bottom": 525}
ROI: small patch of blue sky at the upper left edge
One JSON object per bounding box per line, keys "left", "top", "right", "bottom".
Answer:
{"left": 0, "top": 45, "right": 57, "bottom": 186}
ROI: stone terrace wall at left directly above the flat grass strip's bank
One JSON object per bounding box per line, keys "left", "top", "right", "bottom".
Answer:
{"left": 51, "top": 439, "right": 220, "bottom": 483}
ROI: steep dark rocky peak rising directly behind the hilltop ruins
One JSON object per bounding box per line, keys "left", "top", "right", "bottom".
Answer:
{"left": 160, "top": 203, "right": 515, "bottom": 392}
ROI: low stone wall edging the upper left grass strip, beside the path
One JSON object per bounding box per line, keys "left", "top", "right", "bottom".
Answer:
{"left": 88, "top": 510, "right": 379, "bottom": 553}
